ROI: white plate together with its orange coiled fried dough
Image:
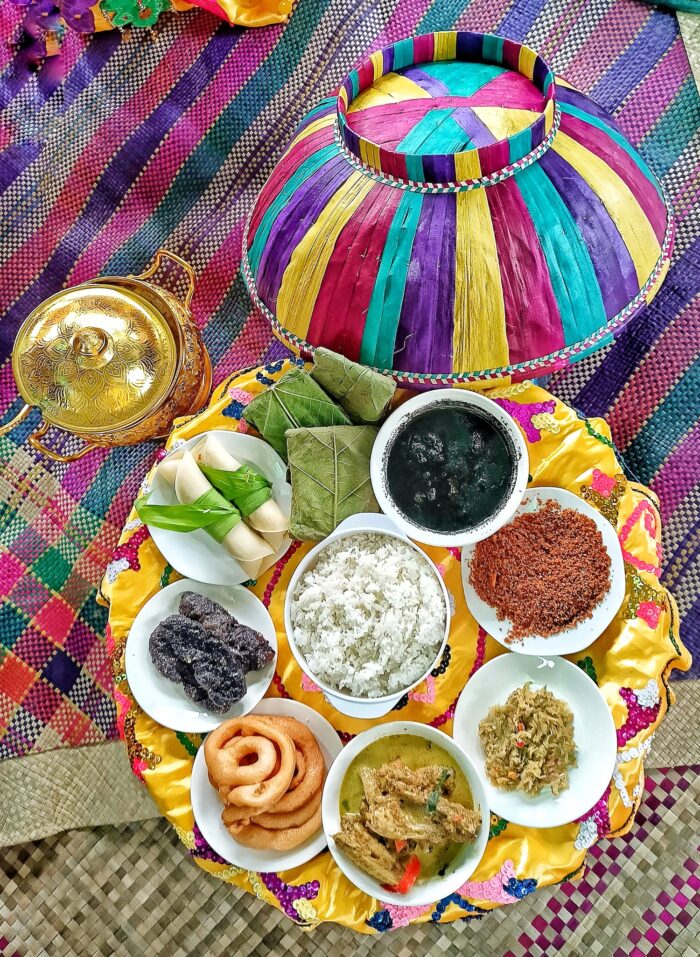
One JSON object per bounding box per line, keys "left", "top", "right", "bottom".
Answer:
{"left": 191, "top": 698, "right": 342, "bottom": 871}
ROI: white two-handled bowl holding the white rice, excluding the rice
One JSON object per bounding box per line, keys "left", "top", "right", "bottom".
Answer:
{"left": 284, "top": 513, "right": 450, "bottom": 718}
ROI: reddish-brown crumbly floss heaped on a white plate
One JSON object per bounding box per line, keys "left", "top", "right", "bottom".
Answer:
{"left": 470, "top": 501, "right": 610, "bottom": 641}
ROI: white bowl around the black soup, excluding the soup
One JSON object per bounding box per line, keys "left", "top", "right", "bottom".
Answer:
{"left": 370, "top": 389, "right": 528, "bottom": 548}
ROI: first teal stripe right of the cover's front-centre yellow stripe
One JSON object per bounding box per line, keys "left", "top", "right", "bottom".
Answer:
{"left": 515, "top": 163, "right": 606, "bottom": 345}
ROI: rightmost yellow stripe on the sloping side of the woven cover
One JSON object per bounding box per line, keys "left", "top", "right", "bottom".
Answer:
{"left": 552, "top": 130, "right": 661, "bottom": 287}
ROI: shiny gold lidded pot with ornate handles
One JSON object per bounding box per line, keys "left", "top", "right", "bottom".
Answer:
{"left": 0, "top": 249, "right": 212, "bottom": 462}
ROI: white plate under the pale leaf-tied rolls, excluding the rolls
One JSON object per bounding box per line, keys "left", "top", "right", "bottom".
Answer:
{"left": 148, "top": 430, "right": 292, "bottom": 585}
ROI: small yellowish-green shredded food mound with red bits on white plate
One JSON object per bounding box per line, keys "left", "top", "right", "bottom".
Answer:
{"left": 479, "top": 682, "right": 576, "bottom": 796}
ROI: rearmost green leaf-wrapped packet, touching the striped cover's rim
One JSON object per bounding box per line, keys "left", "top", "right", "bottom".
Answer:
{"left": 311, "top": 347, "right": 396, "bottom": 424}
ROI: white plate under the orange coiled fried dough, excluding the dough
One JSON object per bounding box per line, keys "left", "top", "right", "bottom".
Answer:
{"left": 190, "top": 698, "right": 343, "bottom": 871}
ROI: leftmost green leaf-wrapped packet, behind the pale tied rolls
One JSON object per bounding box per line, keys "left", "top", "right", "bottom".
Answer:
{"left": 243, "top": 369, "right": 350, "bottom": 462}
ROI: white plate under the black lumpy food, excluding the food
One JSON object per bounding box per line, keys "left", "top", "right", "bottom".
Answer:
{"left": 125, "top": 578, "right": 277, "bottom": 731}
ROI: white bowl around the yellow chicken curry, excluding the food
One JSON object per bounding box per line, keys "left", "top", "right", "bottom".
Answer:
{"left": 322, "top": 721, "right": 490, "bottom": 907}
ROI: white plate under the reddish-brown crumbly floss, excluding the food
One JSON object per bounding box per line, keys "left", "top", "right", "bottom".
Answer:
{"left": 462, "top": 488, "right": 625, "bottom": 655}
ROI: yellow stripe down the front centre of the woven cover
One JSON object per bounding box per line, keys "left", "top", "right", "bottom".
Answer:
{"left": 452, "top": 189, "right": 508, "bottom": 371}
